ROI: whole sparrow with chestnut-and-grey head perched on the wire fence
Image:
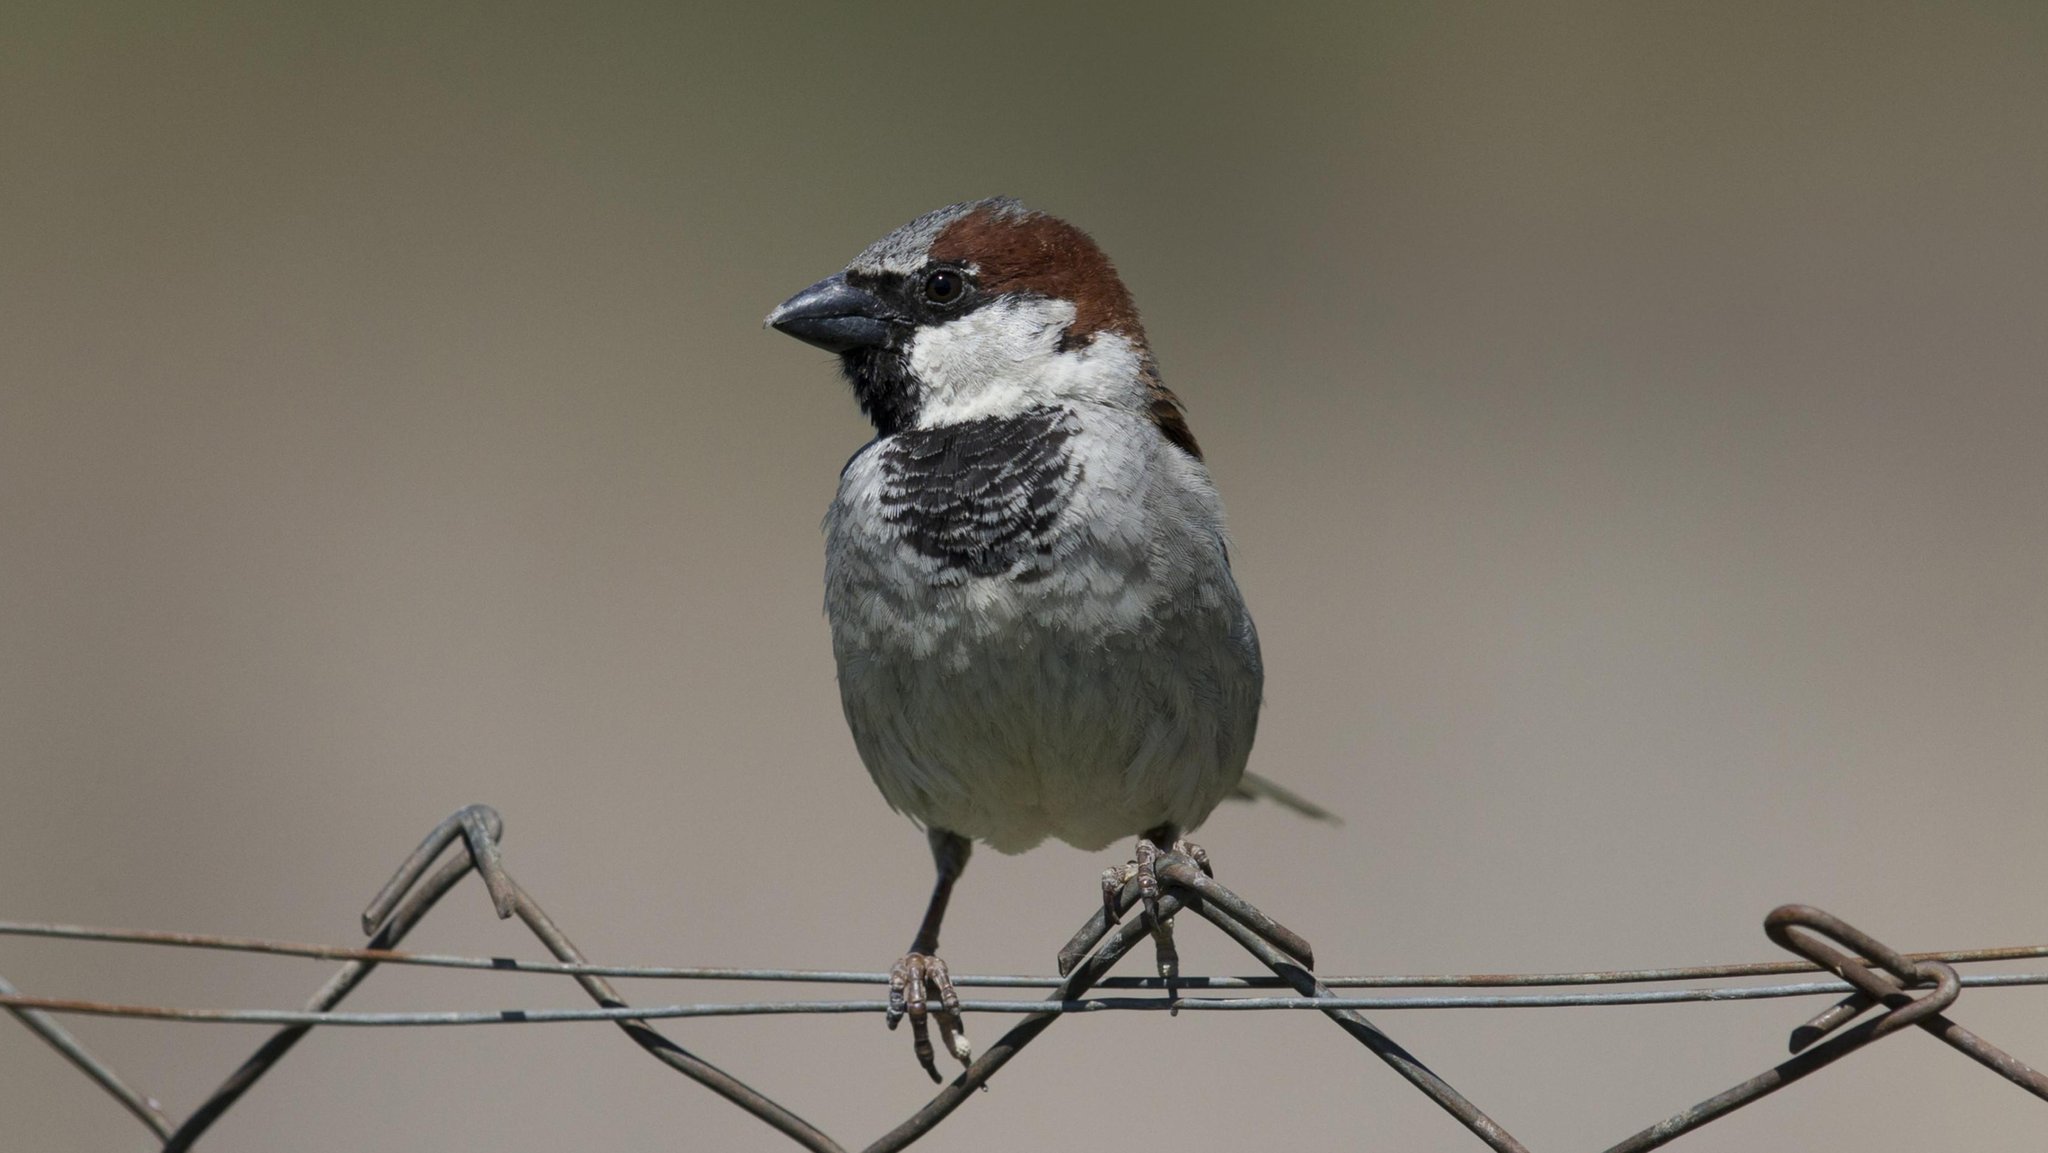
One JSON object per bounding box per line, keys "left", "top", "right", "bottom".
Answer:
{"left": 766, "top": 197, "right": 1327, "bottom": 1081}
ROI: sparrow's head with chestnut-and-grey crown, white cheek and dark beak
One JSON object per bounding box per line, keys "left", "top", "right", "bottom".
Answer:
{"left": 768, "top": 197, "right": 1200, "bottom": 457}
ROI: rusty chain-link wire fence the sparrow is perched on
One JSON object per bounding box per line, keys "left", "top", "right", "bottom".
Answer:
{"left": 0, "top": 805, "right": 2048, "bottom": 1153}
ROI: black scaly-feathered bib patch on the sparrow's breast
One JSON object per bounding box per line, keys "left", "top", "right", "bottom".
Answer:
{"left": 881, "top": 408, "right": 1079, "bottom": 580}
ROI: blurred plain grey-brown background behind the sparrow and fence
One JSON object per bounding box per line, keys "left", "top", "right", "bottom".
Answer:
{"left": 0, "top": 2, "right": 2048, "bottom": 1153}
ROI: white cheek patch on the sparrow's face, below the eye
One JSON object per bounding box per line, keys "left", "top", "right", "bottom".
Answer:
{"left": 909, "top": 297, "right": 1143, "bottom": 426}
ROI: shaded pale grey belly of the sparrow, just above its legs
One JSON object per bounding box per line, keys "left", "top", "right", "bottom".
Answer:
{"left": 838, "top": 565, "right": 1260, "bottom": 852}
